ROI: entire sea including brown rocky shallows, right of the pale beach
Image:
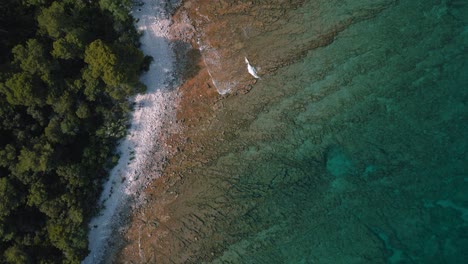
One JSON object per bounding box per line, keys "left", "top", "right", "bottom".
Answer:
{"left": 119, "top": 0, "right": 468, "bottom": 263}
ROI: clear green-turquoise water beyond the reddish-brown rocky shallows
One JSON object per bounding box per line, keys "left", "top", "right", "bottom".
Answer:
{"left": 194, "top": 1, "right": 468, "bottom": 263}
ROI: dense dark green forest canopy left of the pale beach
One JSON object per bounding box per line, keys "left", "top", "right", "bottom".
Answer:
{"left": 0, "top": 0, "right": 150, "bottom": 263}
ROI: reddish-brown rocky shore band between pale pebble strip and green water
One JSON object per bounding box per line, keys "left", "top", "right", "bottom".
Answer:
{"left": 117, "top": 0, "right": 391, "bottom": 263}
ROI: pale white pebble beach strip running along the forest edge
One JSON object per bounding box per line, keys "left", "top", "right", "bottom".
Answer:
{"left": 83, "top": 0, "right": 181, "bottom": 263}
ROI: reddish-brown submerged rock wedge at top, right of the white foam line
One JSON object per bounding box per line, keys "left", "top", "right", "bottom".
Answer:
{"left": 182, "top": 0, "right": 395, "bottom": 94}
